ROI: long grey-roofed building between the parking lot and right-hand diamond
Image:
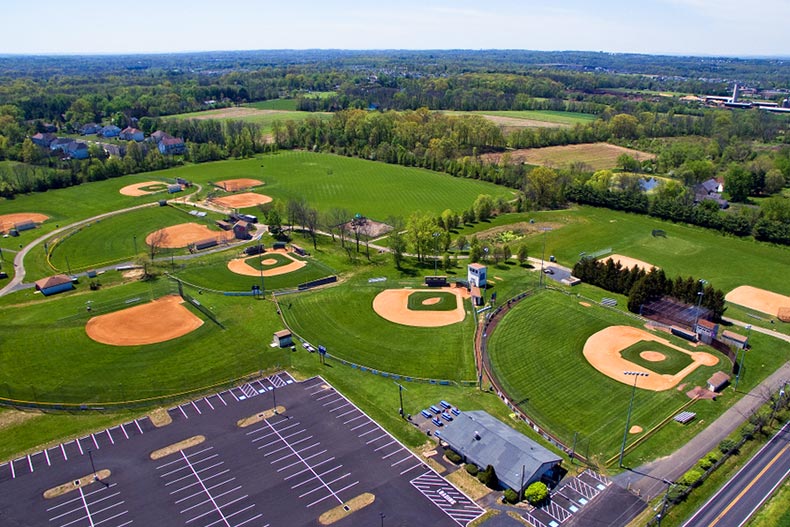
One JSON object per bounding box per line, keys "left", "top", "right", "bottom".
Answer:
{"left": 440, "top": 411, "right": 562, "bottom": 492}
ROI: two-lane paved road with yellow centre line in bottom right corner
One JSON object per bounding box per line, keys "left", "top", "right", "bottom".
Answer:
{"left": 683, "top": 422, "right": 790, "bottom": 527}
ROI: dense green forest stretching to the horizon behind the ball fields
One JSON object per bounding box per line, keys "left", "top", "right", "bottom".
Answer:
{"left": 0, "top": 50, "right": 790, "bottom": 244}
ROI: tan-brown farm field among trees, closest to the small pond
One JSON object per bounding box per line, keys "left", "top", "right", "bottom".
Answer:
{"left": 482, "top": 143, "right": 655, "bottom": 170}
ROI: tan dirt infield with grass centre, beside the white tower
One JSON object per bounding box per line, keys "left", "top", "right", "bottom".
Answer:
{"left": 373, "top": 287, "right": 466, "bottom": 328}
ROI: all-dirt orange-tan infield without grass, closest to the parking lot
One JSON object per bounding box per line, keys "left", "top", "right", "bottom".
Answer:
{"left": 85, "top": 295, "right": 203, "bottom": 346}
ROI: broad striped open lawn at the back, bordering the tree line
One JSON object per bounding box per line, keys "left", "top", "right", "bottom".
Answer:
{"left": 151, "top": 151, "right": 513, "bottom": 221}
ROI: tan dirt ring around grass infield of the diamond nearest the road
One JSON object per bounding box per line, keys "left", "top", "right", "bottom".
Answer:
{"left": 584, "top": 326, "right": 719, "bottom": 392}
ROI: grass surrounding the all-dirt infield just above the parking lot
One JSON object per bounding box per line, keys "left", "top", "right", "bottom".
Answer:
{"left": 0, "top": 279, "right": 290, "bottom": 403}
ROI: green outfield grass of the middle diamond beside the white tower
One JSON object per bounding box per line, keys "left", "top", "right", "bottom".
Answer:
{"left": 279, "top": 283, "right": 475, "bottom": 381}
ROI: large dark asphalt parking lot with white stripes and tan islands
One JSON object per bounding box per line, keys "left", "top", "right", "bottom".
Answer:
{"left": 0, "top": 373, "right": 484, "bottom": 527}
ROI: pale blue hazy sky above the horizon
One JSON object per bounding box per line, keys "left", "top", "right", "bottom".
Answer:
{"left": 0, "top": 0, "right": 790, "bottom": 57}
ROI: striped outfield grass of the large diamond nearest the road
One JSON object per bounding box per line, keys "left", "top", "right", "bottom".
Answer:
{"left": 489, "top": 291, "right": 723, "bottom": 461}
